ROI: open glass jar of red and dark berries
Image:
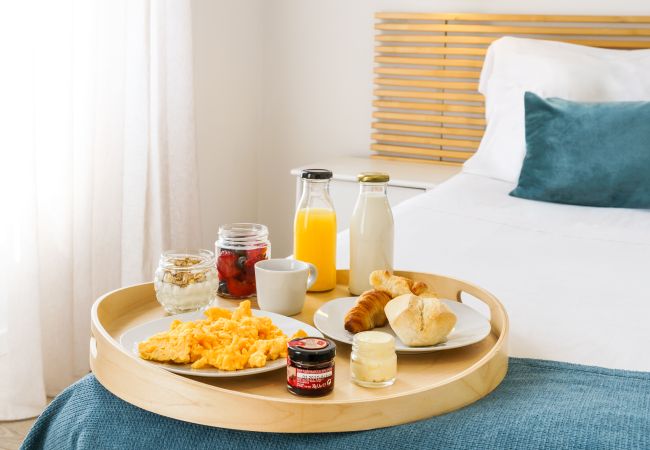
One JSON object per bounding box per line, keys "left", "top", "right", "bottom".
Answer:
{"left": 215, "top": 223, "right": 271, "bottom": 299}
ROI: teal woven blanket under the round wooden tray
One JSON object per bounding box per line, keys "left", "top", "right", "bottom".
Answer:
{"left": 22, "top": 358, "right": 650, "bottom": 450}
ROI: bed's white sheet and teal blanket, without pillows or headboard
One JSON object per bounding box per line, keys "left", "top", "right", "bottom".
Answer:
{"left": 24, "top": 174, "right": 650, "bottom": 449}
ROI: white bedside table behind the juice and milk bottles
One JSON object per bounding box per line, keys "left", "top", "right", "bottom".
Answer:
{"left": 291, "top": 156, "right": 462, "bottom": 231}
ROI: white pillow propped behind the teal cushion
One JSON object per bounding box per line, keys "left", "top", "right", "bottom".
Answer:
{"left": 463, "top": 37, "right": 650, "bottom": 183}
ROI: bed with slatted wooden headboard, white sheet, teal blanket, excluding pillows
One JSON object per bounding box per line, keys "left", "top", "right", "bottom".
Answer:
{"left": 19, "top": 13, "right": 650, "bottom": 449}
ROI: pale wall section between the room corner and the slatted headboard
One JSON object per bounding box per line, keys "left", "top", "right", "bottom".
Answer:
{"left": 258, "top": 1, "right": 373, "bottom": 256}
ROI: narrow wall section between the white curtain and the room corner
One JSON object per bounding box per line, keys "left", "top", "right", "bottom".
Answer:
{"left": 192, "top": 0, "right": 264, "bottom": 249}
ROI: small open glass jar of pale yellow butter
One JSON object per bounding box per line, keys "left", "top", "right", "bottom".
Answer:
{"left": 350, "top": 331, "right": 397, "bottom": 387}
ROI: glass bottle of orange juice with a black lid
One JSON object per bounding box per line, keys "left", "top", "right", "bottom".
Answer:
{"left": 293, "top": 169, "right": 336, "bottom": 292}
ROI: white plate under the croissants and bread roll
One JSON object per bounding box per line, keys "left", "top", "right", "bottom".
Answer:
{"left": 314, "top": 297, "right": 491, "bottom": 353}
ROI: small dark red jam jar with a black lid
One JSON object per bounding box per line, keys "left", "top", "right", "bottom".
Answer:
{"left": 287, "top": 337, "right": 336, "bottom": 397}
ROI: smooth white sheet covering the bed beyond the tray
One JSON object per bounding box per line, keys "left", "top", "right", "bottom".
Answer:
{"left": 338, "top": 173, "right": 650, "bottom": 371}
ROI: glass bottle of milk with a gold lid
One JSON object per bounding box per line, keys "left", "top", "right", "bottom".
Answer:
{"left": 350, "top": 172, "right": 394, "bottom": 295}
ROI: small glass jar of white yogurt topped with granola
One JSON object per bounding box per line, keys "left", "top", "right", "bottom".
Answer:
{"left": 154, "top": 250, "right": 218, "bottom": 314}
